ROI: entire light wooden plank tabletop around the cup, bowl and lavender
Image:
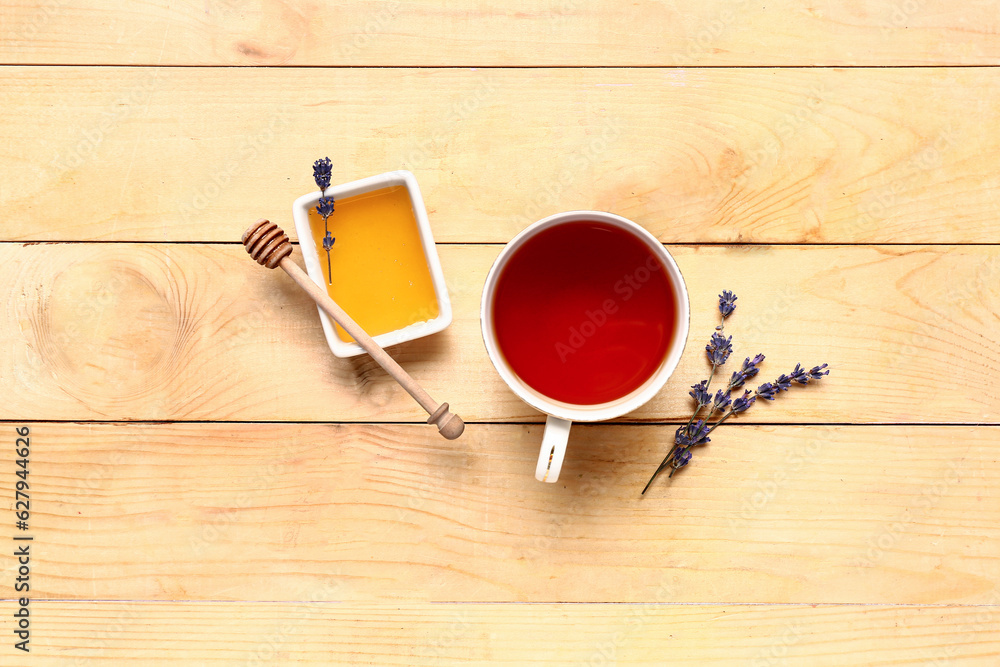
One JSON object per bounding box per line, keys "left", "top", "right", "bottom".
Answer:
{"left": 0, "top": 0, "right": 1000, "bottom": 666}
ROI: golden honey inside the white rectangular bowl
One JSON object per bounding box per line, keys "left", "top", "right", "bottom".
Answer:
{"left": 309, "top": 186, "right": 440, "bottom": 342}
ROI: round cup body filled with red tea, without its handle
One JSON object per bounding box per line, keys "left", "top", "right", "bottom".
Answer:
{"left": 482, "top": 211, "right": 688, "bottom": 421}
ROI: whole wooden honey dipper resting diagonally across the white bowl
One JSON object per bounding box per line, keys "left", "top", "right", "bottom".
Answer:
{"left": 243, "top": 219, "right": 465, "bottom": 440}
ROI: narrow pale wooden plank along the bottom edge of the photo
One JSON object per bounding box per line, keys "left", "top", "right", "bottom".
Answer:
{"left": 4, "top": 604, "right": 1000, "bottom": 667}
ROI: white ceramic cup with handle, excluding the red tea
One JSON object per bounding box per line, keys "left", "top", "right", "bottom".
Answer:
{"left": 480, "top": 211, "right": 690, "bottom": 482}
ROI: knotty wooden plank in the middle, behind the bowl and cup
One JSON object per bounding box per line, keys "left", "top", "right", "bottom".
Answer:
{"left": 0, "top": 243, "right": 1000, "bottom": 423}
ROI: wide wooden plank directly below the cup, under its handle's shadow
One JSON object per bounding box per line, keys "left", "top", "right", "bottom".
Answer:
{"left": 0, "top": 423, "right": 1000, "bottom": 604}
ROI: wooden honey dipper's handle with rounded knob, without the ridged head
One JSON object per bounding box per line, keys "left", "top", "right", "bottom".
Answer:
{"left": 278, "top": 257, "right": 465, "bottom": 440}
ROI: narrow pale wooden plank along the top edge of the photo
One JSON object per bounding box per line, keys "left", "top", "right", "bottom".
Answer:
{"left": 0, "top": 0, "right": 1000, "bottom": 66}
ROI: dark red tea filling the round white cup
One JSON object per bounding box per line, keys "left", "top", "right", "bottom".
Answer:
{"left": 492, "top": 220, "right": 677, "bottom": 405}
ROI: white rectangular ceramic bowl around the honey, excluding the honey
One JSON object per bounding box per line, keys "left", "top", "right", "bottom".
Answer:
{"left": 292, "top": 170, "right": 451, "bottom": 357}
